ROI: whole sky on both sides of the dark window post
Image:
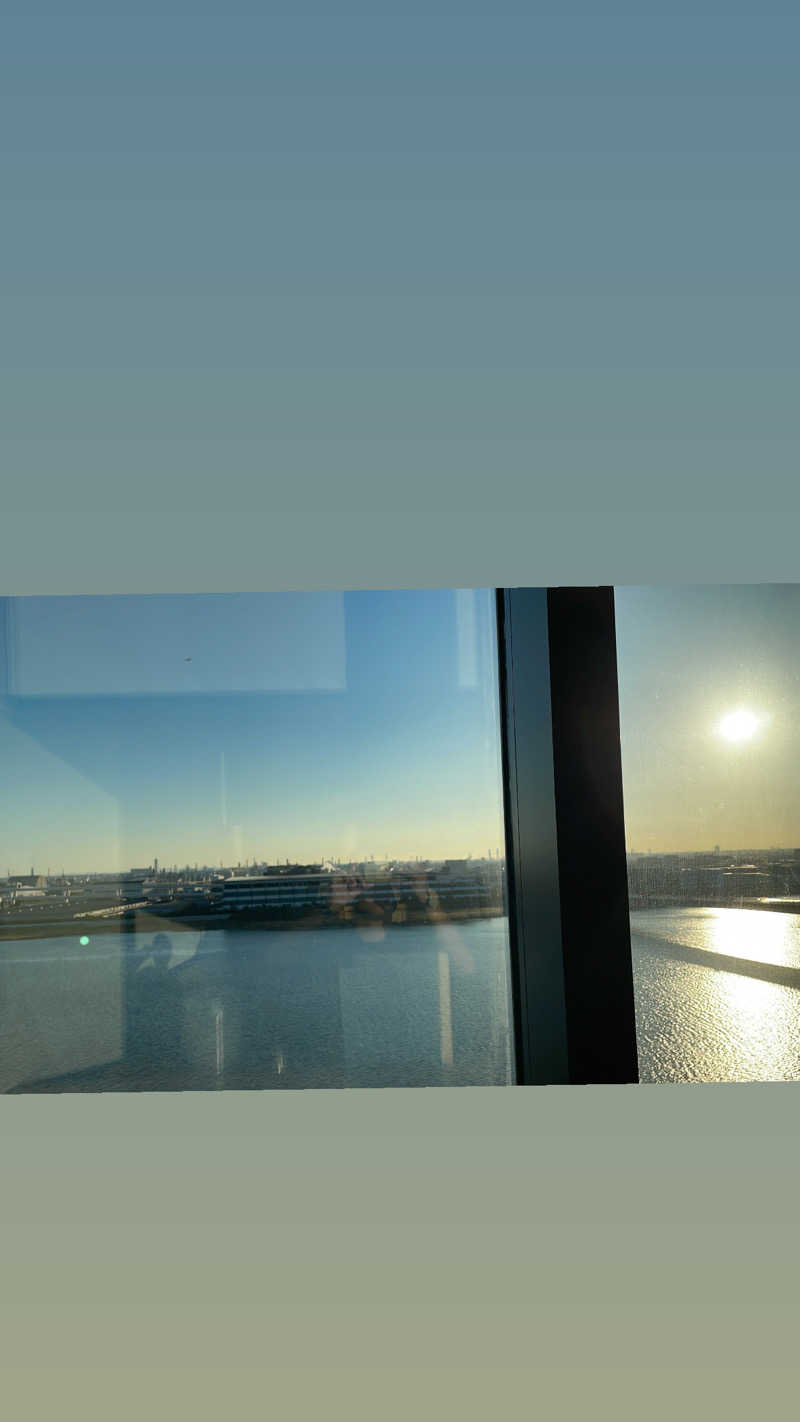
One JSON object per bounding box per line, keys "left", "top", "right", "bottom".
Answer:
{"left": 6, "top": 584, "right": 800, "bottom": 873}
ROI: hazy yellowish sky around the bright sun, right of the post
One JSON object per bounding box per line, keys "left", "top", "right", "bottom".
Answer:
{"left": 615, "top": 584, "right": 800, "bottom": 853}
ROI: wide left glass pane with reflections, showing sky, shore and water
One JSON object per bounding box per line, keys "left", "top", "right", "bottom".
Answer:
{"left": 0, "top": 589, "right": 513, "bottom": 1092}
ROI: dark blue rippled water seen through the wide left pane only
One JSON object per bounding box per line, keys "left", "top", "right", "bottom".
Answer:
{"left": 0, "top": 919, "right": 513, "bottom": 1091}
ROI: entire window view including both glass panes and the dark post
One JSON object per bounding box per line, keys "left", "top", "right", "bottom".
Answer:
{"left": 12, "top": 574, "right": 784, "bottom": 1092}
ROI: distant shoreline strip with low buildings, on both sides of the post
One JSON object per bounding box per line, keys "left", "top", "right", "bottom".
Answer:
{"left": 10, "top": 846, "right": 800, "bottom": 924}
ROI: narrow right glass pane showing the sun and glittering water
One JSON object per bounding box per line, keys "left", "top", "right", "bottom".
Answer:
{"left": 615, "top": 586, "right": 800, "bottom": 1082}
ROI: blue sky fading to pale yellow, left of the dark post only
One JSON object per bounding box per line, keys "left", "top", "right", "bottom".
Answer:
{"left": 0, "top": 589, "right": 503, "bottom": 873}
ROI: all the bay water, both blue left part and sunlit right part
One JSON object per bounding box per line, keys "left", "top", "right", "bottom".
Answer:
{"left": 6, "top": 909, "right": 800, "bottom": 1092}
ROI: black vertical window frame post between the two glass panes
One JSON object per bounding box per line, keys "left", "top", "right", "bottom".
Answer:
{"left": 496, "top": 587, "right": 639, "bottom": 1085}
